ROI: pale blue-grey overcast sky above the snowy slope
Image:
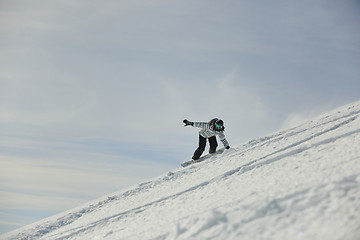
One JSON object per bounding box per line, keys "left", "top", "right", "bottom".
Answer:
{"left": 0, "top": 0, "right": 360, "bottom": 232}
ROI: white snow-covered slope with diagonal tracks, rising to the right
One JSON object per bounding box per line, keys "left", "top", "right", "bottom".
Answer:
{"left": 0, "top": 101, "right": 360, "bottom": 240}
